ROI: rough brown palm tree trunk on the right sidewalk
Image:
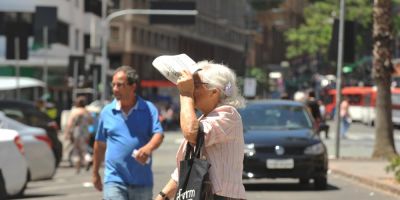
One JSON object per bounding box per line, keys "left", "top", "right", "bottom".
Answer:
{"left": 372, "top": 0, "right": 397, "bottom": 158}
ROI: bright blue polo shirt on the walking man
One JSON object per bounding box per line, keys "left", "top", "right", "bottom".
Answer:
{"left": 96, "top": 97, "right": 163, "bottom": 186}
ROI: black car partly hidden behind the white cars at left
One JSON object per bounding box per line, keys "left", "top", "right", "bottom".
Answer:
{"left": 0, "top": 100, "right": 63, "bottom": 166}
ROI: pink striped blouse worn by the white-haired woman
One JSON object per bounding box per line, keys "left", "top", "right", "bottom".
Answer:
{"left": 171, "top": 105, "right": 246, "bottom": 199}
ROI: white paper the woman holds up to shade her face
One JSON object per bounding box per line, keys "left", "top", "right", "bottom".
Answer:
{"left": 152, "top": 54, "right": 199, "bottom": 85}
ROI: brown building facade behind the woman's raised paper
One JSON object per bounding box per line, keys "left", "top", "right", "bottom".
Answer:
{"left": 109, "top": 0, "right": 255, "bottom": 85}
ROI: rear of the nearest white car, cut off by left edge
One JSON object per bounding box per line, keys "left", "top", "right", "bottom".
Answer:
{"left": 0, "top": 129, "right": 28, "bottom": 199}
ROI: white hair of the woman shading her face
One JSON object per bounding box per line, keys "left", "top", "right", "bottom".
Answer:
{"left": 197, "top": 60, "right": 245, "bottom": 108}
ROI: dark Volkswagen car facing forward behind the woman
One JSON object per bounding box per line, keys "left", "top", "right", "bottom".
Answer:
{"left": 239, "top": 100, "right": 328, "bottom": 189}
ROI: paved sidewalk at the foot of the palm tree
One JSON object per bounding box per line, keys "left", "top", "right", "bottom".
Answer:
{"left": 329, "top": 155, "right": 400, "bottom": 196}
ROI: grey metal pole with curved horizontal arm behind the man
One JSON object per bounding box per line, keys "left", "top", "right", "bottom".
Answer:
{"left": 101, "top": 7, "right": 198, "bottom": 104}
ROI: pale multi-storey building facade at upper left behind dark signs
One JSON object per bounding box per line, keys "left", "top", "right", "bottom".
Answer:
{"left": 0, "top": 0, "right": 101, "bottom": 107}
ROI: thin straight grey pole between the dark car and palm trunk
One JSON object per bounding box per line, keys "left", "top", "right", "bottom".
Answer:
{"left": 335, "top": 0, "right": 346, "bottom": 159}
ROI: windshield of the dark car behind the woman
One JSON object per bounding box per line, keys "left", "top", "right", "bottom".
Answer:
{"left": 240, "top": 105, "right": 312, "bottom": 130}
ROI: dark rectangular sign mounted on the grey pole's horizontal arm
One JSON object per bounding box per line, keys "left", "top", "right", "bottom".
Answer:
{"left": 149, "top": 1, "right": 196, "bottom": 25}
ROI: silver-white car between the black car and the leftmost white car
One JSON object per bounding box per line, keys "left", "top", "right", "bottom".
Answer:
{"left": 0, "top": 112, "right": 56, "bottom": 180}
